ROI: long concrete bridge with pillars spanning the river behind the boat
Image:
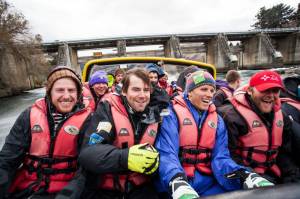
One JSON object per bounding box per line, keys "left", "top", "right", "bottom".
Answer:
{"left": 43, "top": 27, "right": 300, "bottom": 71}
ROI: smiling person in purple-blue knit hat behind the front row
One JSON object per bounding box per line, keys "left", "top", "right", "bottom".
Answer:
{"left": 83, "top": 70, "right": 109, "bottom": 111}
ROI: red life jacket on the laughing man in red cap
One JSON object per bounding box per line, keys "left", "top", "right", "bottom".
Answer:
{"left": 230, "top": 91, "right": 283, "bottom": 177}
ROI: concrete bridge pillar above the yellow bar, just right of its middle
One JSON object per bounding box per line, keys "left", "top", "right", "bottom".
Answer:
{"left": 164, "top": 35, "right": 182, "bottom": 58}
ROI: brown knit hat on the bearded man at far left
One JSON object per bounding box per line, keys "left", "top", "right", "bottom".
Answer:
{"left": 46, "top": 66, "right": 82, "bottom": 96}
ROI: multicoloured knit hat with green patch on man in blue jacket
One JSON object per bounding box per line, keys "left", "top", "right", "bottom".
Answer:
{"left": 185, "top": 71, "right": 216, "bottom": 93}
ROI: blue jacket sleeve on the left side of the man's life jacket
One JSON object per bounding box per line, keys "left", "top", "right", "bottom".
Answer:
{"left": 155, "top": 107, "right": 184, "bottom": 190}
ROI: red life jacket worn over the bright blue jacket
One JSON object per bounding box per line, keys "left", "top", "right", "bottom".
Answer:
{"left": 173, "top": 96, "right": 218, "bottom": 177}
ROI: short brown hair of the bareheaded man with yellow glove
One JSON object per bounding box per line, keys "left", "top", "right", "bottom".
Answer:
{"left": 122, "top": 68, "right": 151, "bottom": 93}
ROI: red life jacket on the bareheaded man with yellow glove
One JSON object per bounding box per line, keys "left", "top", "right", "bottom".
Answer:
{"left": 100, "top": 94, "right": 158, "bottom": 192}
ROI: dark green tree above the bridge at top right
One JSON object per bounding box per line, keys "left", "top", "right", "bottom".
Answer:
{"left": 252, "top": 3, "right": 296, "bottom": 28}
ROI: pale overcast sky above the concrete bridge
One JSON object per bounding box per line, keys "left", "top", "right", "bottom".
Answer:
{"left": 7, "top": 0, "right": 299, "bottom": 42}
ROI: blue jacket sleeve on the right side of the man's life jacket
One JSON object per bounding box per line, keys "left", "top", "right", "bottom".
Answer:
{"left": 212, "top": 115, "right": 246, "bottom": 190}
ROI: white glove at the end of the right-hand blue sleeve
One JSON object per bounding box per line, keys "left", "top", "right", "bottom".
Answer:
{"left": 243, "top": 173, "right": 274, "bottom": 189}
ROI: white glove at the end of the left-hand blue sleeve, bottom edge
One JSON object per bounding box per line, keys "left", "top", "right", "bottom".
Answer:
{"left": 170, "top": 179, "right": 199, "bottom": 199}
